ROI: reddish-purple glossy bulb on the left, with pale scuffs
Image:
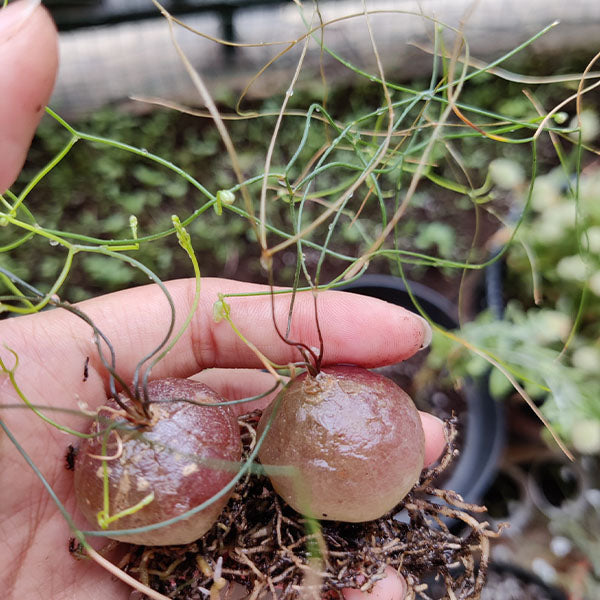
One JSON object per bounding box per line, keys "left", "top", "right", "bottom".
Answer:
{"left": 75, "top": 379, "right": 242, "bottom": 546}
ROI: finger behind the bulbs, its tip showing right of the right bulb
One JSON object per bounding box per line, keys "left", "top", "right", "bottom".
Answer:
{"left": 192, "top": 369, "right": 446, "bottom": 467}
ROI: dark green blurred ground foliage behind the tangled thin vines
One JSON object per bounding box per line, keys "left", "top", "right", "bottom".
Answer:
{"left": 5, "top": 79, "right": 502, "bottom": 301}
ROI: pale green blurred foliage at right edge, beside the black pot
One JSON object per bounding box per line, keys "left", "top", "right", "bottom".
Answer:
{"left": 430, "top": 150, "right": 600, "bottom": 454}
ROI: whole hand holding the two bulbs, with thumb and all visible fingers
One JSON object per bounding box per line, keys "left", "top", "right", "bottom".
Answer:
{"left": 0, "top": 2, "right": 444, "bottom": 600}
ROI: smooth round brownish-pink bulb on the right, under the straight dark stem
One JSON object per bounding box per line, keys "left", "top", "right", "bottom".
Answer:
{"left": 258, "top": 366, "right": 425, "bottom": 522}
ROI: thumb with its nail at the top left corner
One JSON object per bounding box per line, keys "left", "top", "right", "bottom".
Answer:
{"left": 0, "top": 0, "right": 58, "bottom": 193}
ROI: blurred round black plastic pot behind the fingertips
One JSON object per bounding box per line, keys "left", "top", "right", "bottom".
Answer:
{"left": 343, "top": 275, "right": 504, "bottom": 503}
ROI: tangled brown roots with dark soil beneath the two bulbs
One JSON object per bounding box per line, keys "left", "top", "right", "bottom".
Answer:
{"left": 120, "top": 411, "right": 500, "bottom": 600}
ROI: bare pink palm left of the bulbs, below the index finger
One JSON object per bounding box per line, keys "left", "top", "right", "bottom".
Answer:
{"left": 0, "top": 372, "right": 129, "bottom": 600}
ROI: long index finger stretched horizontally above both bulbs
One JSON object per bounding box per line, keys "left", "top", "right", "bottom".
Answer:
{"left": 3, "top": 279, "right": 431, "bottom": 400}
